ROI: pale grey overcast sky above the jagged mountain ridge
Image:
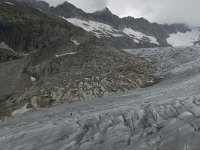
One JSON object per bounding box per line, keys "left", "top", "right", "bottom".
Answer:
{"left": 45, "top": 0, "right": 200, "bottom": 26}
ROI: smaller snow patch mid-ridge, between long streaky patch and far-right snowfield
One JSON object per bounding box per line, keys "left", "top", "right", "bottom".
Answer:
{"left": 123, "top": 28, "right": 159, "bottom": 45}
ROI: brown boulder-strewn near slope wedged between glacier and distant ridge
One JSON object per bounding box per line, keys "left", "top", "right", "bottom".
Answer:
{"left": 0, "top": 0, "right": 157, "bottom": 117}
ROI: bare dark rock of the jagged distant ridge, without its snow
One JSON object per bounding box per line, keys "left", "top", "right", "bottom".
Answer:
{"left": 32, "top": 2, "right": 191, "bottom": 48}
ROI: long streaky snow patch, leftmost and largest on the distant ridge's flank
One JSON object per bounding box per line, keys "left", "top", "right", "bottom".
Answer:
{"left": 61, "top": 17, "right": 123, "bottom": 37}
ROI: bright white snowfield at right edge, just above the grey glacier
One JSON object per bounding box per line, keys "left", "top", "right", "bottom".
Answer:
{"left": 167, "top": 29, "right": 200, "bottom": 46}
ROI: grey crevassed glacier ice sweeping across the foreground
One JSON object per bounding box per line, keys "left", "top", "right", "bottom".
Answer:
{"left": 0, "top": 46, "right": 200, "bottom": 150}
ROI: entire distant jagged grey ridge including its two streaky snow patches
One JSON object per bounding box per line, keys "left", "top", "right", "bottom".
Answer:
{"left": 17, "top": 0, "right": 197, "bottom": 48}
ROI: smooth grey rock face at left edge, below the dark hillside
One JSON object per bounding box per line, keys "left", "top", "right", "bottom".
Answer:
{"left": 0, "top": 58, "right": 31, "bottom": 101}
